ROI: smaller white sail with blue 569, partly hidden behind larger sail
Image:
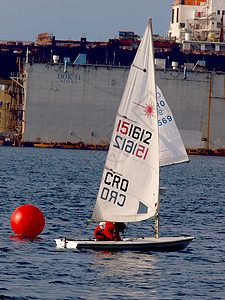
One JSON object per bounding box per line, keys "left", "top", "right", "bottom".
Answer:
{"left": 157, "top": 86, "right": 189, "bottom": 167}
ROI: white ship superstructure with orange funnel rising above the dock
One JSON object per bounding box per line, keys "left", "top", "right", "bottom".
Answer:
{"left": 168, "top": 0, "right": 225, "bottom": 42}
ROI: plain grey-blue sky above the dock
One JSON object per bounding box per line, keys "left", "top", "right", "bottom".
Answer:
{"left": 0, "top": 0, "right": 175, "bottom": 41}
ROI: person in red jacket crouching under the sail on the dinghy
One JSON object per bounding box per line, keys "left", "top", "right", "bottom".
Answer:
{"left": 94, "top": 222, "right": 126, "bottom": 241}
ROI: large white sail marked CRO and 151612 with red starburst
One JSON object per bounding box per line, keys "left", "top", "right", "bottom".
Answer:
{"left": 92, "top": 19, "right": 159, "bottom": 222}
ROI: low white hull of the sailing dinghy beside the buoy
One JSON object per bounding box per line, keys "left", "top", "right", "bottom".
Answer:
{"left": 55, "top": 237, "right": 194, "bottom": 252}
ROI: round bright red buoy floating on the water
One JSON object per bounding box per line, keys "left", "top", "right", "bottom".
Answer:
{"left": 11, "top": 205, "right": 45, "bottom": 237}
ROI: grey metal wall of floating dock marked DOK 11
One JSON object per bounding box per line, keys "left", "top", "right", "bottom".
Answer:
{"left": 22, "top": 63, "right": 225, "bottom": 149}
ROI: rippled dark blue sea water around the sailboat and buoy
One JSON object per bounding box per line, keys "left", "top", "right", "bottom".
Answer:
{"left": 0, "top": 147, "right": 225, "bottom": 300}
